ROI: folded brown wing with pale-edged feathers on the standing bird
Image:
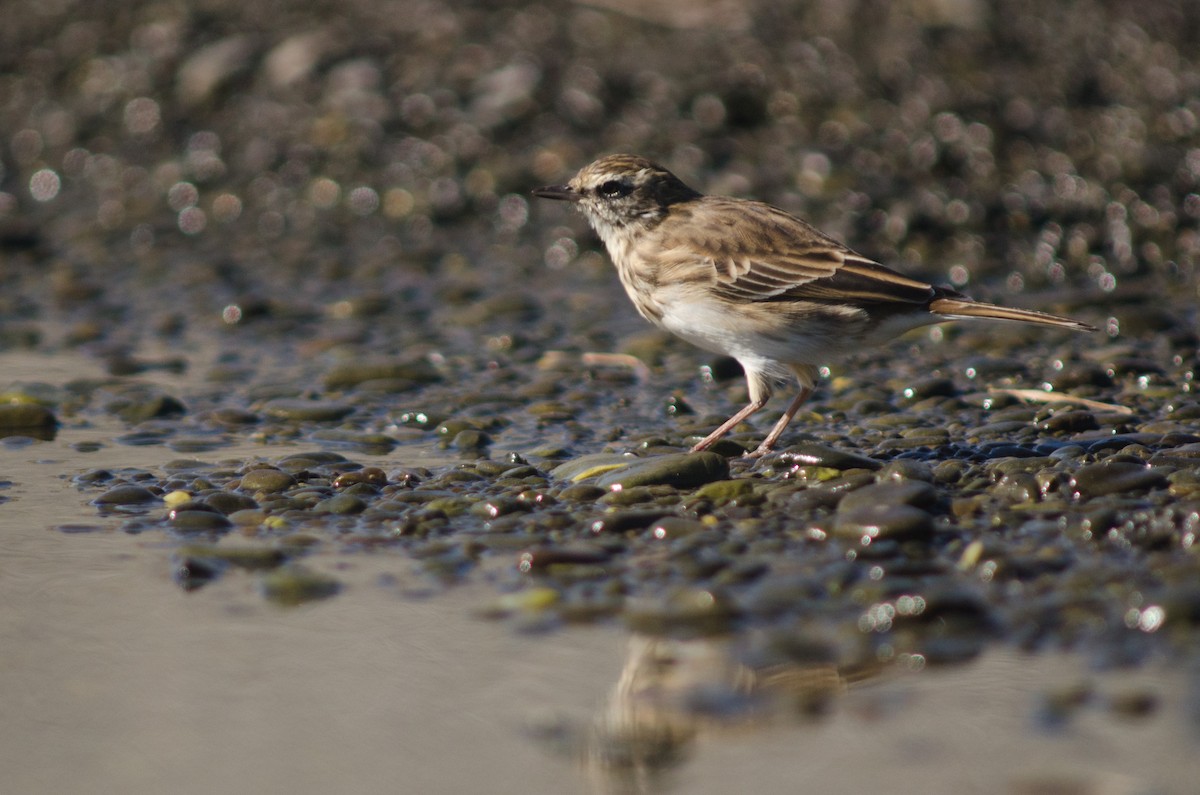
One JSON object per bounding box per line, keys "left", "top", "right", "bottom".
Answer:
{"left": 662, "top": 197, "right": 937, "bottom": 304}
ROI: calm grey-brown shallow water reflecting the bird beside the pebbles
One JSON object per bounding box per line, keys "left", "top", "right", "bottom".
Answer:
{"left": 0, "top": 354, "right": 1200, "bottom": 794}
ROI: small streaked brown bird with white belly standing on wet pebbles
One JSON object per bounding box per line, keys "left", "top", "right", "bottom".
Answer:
{"left": 534, "top": 155, "right": 1096, "bottom": 456}
